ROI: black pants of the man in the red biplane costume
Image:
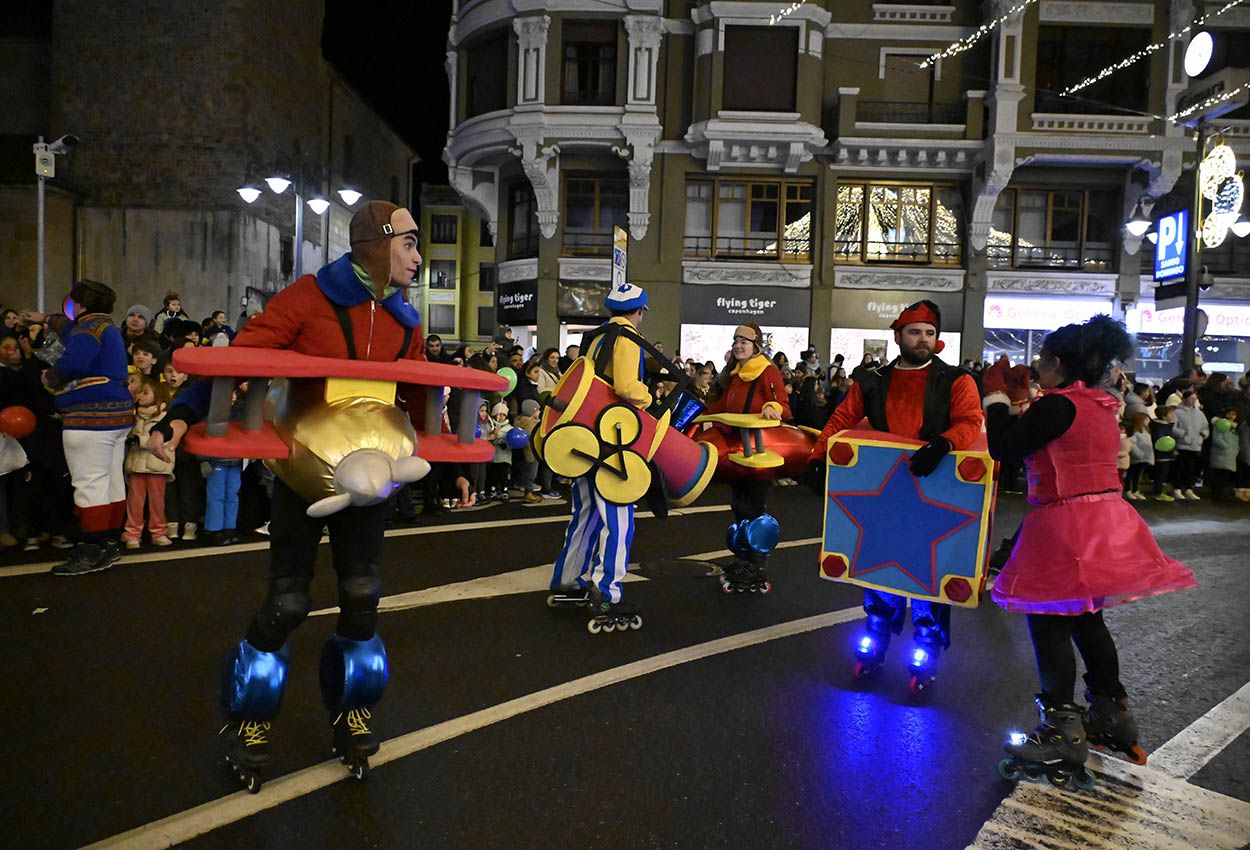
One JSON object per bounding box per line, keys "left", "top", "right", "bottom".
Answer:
{"left": 248, "top": 480, "right": 391, "bottom": 653}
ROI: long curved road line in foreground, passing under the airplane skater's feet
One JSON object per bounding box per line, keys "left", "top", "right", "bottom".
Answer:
{"left": 89, "top": 608, "right": 863, "bottom": 850}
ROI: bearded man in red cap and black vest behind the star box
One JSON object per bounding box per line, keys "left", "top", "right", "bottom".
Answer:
{"left": 811, "top": 300, "right": 981, "bottom": 686}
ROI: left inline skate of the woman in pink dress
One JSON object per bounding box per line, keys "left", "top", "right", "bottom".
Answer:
{"left": 998, "top": 694, "right": 1094, "bottom": 790}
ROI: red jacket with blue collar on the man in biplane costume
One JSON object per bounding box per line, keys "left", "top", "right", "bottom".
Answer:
{"left": 231, "top": 254, "right": 425, "bottom": 360}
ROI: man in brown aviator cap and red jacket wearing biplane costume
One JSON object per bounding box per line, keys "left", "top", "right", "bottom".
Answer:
{"left": 150, "top": 201, "right": 425, "bottom": 793}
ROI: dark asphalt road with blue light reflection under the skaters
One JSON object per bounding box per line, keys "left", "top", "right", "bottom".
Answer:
{"left": 0, "top": 488, "right": 1250, "bottom": 850}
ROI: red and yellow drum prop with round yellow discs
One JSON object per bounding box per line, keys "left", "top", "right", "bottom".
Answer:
{"left": 534, "top": 358, "right": 716, "bottom": 508}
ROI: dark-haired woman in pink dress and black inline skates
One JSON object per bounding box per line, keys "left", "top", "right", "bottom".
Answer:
{"left": 984, "top": 316, "right": 1196, "bottom": 784}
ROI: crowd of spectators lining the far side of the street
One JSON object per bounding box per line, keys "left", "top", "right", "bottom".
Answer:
{"left": 0, "top": 298, "right": 1250, "bottom": 550}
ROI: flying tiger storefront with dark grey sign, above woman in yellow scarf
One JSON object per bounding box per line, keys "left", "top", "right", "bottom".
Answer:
{"left": 681, "top": 284, "right": 811, "bottom": 364}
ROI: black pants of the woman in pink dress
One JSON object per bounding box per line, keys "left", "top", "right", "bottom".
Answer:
{"left": 1029, "top": 611, "right": 1124, "bottom": 704}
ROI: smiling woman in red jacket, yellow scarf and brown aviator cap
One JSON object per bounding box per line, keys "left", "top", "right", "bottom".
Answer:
{"left": 708, "top": 321, "right": 790, "bottom": 593}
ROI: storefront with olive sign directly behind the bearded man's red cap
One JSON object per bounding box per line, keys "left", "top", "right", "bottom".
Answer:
{"left": 825, "top": 289, "right": 964, "bottom": 370}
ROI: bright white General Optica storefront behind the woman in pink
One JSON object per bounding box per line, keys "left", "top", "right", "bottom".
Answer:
{"left": 981, "top": 294, "right": 1114, "bottom": 364}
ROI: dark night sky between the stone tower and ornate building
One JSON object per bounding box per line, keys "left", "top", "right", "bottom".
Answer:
{"left": 321, "top": 0, "right": 451, "bottom": 184}
